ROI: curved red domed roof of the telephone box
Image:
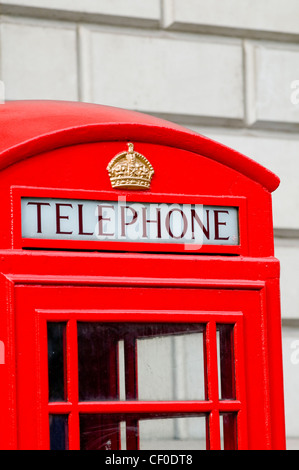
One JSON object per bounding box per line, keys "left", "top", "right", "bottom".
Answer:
{"left": 0, "top": 100, "right": 280, "bottom": 192}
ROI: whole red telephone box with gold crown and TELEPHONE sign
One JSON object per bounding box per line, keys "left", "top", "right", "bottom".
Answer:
{"left": 0, "top": 101, "right": 285, "bottom": 450}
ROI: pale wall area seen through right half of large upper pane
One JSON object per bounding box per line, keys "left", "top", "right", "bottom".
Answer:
{"left": 137, "top": 325, "right": 205, "bottom": 400}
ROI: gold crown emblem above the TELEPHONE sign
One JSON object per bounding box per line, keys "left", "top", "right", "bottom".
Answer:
{"left": 107, "top": 143, "right": 154, "bottom": 189}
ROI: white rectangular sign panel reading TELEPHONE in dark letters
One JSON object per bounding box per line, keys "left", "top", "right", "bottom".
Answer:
{"left": 21, "top": 197, "right": 239, "bottom": 245}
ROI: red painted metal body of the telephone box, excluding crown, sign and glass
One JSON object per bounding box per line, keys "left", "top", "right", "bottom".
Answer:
{"left": 0, "top": 102, "right": 285, "bottom": 449}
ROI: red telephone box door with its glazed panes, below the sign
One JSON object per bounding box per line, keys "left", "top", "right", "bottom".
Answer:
{"left": 14, "top": 279, "right": 271, "bottom": 450}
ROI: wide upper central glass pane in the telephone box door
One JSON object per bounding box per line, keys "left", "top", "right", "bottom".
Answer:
{"left": 78, "top": 322, "right": 205, "bottom": 401}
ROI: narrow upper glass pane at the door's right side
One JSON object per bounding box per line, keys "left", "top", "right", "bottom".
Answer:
{"left": 217, "top": 324, "right": 236, "bottom": 400}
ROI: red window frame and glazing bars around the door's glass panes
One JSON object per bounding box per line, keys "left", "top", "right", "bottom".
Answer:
{"left": 36, "top": 309, "right": 247, "bottom": 450}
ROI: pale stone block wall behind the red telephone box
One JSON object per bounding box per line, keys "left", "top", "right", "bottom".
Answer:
{"left": 0, "top": 0, "right": 299, "bottom": 448}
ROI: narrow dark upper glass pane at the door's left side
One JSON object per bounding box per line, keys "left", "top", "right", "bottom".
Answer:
{"left": 47, "top": 322, "right": 66, "bottom": 402}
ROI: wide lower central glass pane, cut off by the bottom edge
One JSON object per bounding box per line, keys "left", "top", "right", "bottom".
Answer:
{"left": 80, "top": 414, "right": 206, "bottom": 450}
